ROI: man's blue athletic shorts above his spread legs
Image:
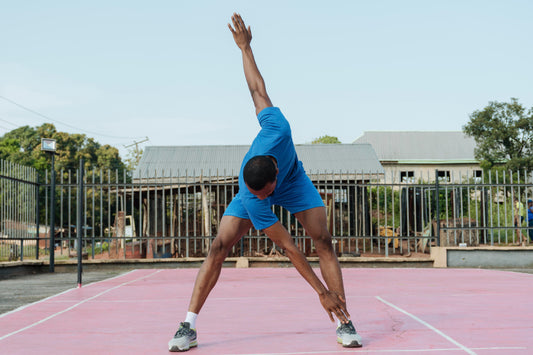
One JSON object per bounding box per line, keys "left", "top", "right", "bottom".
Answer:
{"left": 224, "top": 169, "right": 324, "bottom": 225}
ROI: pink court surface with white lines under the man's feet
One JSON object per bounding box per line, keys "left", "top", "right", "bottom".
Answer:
{"left": 0, "top": 268, "right": 533, "bottom": 355}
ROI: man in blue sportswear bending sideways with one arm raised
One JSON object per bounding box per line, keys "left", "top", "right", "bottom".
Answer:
{"left": 168, "top": 14, "right": 362, "bottom": 351}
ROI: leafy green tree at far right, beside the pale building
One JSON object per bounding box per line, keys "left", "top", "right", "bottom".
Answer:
{"left": 463, "top": 98, "right": 533, "bottom": 170}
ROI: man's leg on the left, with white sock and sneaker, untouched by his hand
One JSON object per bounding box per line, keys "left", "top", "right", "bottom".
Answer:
{"left": 168, "top": 216, "right": 252, "bottom": 351}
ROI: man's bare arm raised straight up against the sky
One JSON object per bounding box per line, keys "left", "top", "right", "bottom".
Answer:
{"left": 228, "top": 13, "right": 272, "bottom": 114}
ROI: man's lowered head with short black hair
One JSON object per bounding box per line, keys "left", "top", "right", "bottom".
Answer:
{"left": 242, "top": 155, "right": 278, "bottom": 200}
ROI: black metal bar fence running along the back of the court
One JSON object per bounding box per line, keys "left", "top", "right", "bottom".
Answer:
{"left": 0, "top": 162, "right": 533, "bottom": 260}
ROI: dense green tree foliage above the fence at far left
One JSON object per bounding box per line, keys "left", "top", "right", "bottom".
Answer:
{"left": 0, "top": 123, "right": 125, "bottom": 178}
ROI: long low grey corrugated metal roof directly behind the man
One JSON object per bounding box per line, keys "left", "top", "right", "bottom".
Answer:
{"left": 133, "top": 144, "right": 384, "bottom": 179}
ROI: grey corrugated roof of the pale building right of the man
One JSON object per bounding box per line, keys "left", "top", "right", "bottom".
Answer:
{"left": 354, "top": 131, "right": 477, "bottom": 162}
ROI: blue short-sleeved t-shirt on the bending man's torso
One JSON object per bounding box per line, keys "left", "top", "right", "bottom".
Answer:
{"left": 239, "top": 107, "right": 305, "bottom": 229}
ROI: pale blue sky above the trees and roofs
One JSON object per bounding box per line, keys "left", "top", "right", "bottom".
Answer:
{"left": 0, "top": 0, "right": 533, "bottom": 157}
